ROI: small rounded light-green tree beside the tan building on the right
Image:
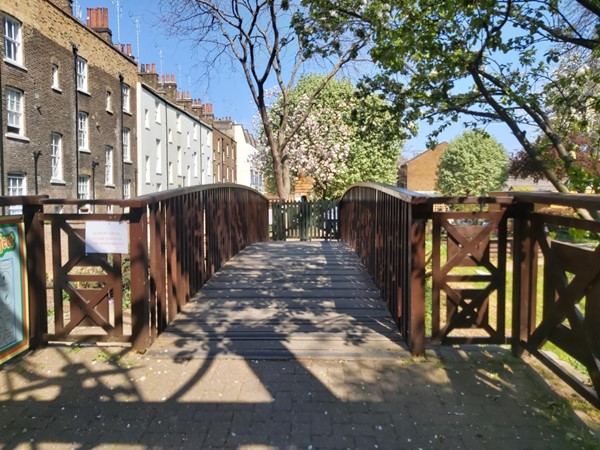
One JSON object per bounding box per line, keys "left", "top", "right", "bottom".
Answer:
{"left": 436, "top": 130, "right": 508, "bottom": 196}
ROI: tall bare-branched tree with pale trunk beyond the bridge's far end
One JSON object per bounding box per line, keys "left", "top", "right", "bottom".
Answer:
{"left": 162, "top": 0, "right": 368, "bottom": 198}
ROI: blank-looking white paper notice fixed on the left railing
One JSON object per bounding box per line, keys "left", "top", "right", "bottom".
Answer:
{"left": 85, "top": 220, "right": 129, "bottom": 253}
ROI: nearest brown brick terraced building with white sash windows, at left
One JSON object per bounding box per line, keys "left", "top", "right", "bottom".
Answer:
{"left": 0, "top": 0, "right": 137, "bottom": 211}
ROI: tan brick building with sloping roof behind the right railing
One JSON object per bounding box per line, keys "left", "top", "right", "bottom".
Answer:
{"left": 398, "top": 142, "right": 448, "bottom": 193}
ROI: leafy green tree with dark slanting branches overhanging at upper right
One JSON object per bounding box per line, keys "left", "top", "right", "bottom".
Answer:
{"left": 302, "top": 0, "right": 600, "bottom": 216}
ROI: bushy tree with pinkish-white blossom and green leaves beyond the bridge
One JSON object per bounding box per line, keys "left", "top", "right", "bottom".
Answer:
{"left": 253, "top": 74, "right": 405, "bottom": 198}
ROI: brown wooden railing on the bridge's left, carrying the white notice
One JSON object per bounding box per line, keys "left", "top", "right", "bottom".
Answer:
{"left": 6, "top": 184, "right": 269, "bottom": 350}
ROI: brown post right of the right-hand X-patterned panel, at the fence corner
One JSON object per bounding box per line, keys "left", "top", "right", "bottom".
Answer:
{"left": 511, "top": 203, "right": 537, "bottom": 356}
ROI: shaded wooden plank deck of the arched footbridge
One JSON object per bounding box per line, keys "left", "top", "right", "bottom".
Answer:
{"left": 150, "top": 242, "right": 408, "bottom": 359}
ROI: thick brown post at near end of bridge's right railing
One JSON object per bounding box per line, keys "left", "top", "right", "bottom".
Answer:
{"left": 407, "top": 205, "right": 427, "bottom": 356}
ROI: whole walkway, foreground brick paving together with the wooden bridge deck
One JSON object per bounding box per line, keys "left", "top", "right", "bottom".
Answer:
{"left": 0, "top": 243, "right": 598, "bottom": 449}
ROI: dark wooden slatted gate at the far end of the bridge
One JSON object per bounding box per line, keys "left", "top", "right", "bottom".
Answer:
{"left": 271, "top": 200, "right": 339, "bottom": 241}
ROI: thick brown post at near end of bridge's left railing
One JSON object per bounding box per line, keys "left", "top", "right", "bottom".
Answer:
{"left": 129, "top": 207, "right": 151, "bottom": 351}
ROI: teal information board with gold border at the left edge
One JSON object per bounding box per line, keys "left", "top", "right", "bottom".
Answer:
{"left": 0, "top": 217, "right": 29, "bottom": 363}
